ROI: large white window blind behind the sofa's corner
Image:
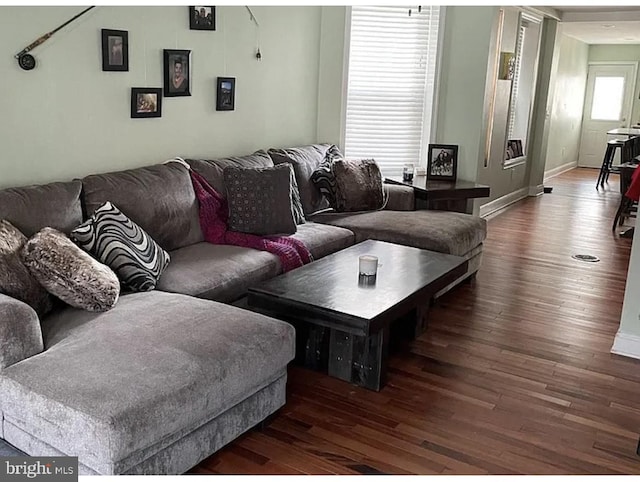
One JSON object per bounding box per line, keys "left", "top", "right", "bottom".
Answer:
{"left": 344, "top": 6, "right": 440, "bottom": 175}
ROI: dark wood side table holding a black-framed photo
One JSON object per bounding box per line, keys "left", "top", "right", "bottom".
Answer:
{"left": 385, "top": 176, "right": 490, "bottom": 214}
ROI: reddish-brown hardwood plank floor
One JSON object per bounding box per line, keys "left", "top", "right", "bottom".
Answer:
{"left": 193, "top": 169, "right": 640, "bottom": 474}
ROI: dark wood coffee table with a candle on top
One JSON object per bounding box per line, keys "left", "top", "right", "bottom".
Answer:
{"left": 247, "top": 239, "right": 467, "bottom": 390}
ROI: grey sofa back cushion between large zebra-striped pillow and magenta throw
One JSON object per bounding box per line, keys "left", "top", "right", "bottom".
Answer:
{"left": 81, "top": 163, "right": 204, "bottom": 250}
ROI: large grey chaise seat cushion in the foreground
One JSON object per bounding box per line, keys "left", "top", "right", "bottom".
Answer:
{"left": 0, "top": 291, "right": 294, "bottom": 471}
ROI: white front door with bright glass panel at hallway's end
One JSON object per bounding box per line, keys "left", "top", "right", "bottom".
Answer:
{"left": 578, "top": 63, "right": 637, "bottom": 167}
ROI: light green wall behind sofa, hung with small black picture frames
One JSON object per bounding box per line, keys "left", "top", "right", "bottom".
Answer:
{"left": 0, "top": 6, "right": 321, "bottom": 187}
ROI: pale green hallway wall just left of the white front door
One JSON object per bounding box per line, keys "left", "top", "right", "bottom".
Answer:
{"left": 545, "top": 35, "right": 589, "bottom": 172}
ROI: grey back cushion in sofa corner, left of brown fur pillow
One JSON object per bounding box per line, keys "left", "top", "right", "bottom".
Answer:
{"left": 268, "top": 144, "right": 339, "bottom": 215}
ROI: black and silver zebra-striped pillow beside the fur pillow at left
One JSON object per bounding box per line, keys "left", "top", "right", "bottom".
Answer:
{"left": 71, "top": 201, "right": 170, "bottom": 291}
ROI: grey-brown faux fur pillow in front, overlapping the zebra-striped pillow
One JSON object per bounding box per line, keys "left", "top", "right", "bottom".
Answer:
{"left": 22, "top": 228, "right": 120, "bottom": 311}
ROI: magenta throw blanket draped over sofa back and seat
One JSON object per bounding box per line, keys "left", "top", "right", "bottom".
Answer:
{"left": 189, "top": 169, "right": 313, "bottom": 272}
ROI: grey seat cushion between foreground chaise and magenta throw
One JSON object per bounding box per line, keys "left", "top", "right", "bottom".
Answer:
{"left": 156, "top": 243, "right": 280, "bottom": 302}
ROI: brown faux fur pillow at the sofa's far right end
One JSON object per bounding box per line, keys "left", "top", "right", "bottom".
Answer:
{"left": 333, "top": 159, "right": 384, "bottom": 212}
